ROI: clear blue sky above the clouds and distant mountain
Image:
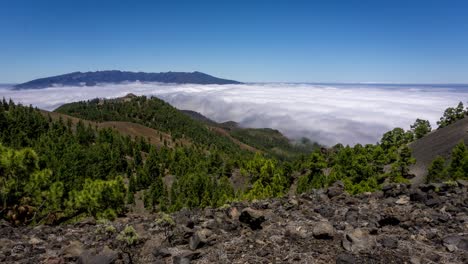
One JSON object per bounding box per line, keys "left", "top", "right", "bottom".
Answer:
{"left": 0, "top": 0, "right": 468, "bottom": 83}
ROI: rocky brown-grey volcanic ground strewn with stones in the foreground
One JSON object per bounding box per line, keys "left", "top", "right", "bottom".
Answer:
{"left": 0, "top": 181, "right": 468, "bottom": 264}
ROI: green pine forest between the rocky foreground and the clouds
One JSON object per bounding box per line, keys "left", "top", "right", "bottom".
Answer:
{"left": 0, "top": 97, "right": 468, "bottom": 224}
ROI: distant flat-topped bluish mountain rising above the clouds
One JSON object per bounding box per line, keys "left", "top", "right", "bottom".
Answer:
{"left": 15, "top": 71, "right": 240, "bottom": 89}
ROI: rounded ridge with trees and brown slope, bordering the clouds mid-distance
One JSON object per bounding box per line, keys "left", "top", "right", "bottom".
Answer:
{"left": 55, "top": 95, "right": 318, "bottom": 159}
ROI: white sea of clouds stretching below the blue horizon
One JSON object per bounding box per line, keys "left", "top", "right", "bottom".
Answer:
{"left": 0, "top": 82, "right": 468, "bottom": 145}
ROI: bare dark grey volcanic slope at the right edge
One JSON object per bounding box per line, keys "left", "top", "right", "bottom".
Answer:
{"left": 409, "top": 117, "right": 468, "bottom": 184}
